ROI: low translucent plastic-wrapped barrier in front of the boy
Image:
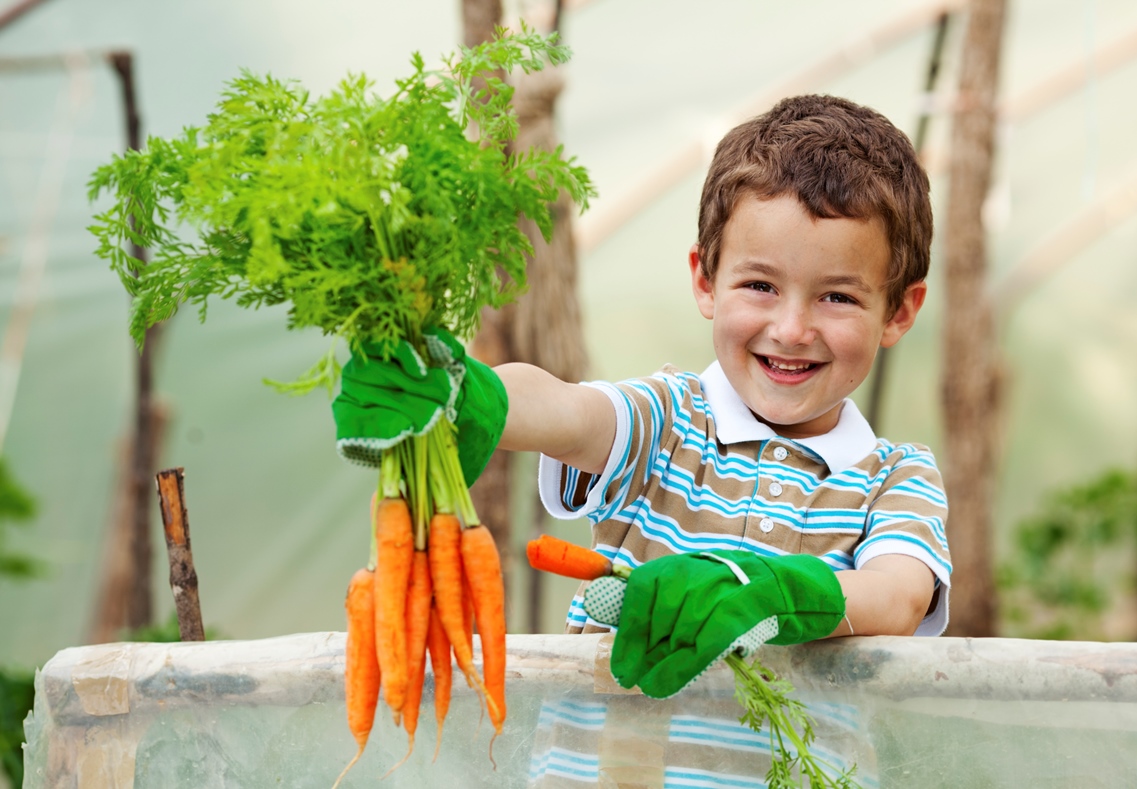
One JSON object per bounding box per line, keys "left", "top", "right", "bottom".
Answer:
{"left": 24, "top": 633, "right": 1137, "bottom": 789}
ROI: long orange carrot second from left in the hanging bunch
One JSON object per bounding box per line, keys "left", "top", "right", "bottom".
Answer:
{"left": 372, "top": 498, "right": 415, "bottom": 725}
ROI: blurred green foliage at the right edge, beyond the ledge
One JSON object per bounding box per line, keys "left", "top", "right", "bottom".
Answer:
{"left": 998, "top": 470, "right": 1137, "bottom": 640}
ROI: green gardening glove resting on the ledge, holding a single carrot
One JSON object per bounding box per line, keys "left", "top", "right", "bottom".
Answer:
{"left": 584, "top": 550, "right": 845, "bottom": 698}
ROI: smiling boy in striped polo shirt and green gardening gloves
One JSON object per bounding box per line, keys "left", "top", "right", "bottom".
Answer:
{"left": 337, "top": 97, "right": 951, "bottom": 698}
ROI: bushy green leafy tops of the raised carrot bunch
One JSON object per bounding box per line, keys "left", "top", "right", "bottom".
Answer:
{"left": 90, "top": 24, "right": 594, "bottom": 393}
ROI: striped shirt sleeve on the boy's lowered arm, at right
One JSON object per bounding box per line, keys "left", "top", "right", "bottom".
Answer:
{"left": 853, "top": 445, "right": 952, "bottom": 636}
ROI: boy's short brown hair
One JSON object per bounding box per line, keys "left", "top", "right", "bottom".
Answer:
{"left": 699, "top": 95, "right": 932, "bottom": 315}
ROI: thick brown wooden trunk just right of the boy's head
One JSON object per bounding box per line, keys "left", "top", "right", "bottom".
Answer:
{"left": 943, "top": 0, "right": 1005, "bottom": 637}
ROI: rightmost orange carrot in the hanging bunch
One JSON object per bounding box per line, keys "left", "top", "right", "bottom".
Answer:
{"left": 462, "top": 525, "right": 505, "bottom": 741}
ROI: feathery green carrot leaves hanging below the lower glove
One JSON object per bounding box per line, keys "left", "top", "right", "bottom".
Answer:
{"left": 727, "top": 654, "right": 857, "bottom": 789}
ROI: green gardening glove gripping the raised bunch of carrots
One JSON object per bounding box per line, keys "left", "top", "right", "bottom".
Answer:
{"left": 332, "top": 329, "right": 508, "bottom": 485}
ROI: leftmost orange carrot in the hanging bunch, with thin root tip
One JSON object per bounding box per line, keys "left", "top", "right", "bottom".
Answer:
{"left": 332, "top": 568, "right": 380, "bottom": 789}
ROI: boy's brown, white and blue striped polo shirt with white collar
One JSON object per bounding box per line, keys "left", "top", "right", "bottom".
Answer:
{"left": 539, "top": 362, "right": 952, "bottom": 636}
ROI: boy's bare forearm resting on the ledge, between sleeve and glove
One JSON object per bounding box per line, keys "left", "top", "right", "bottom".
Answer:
{"left": 831, "top": 555, "right": 935, "bottom": 636}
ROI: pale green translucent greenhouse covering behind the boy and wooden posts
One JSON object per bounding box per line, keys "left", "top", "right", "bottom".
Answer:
{"left": 0, "top": 0, "right": 1137, "bottom": 665}
